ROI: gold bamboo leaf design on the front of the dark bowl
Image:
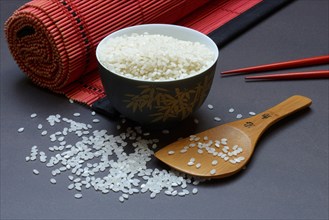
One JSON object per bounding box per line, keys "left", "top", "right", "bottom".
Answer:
{"left": 124, "top": 76, "right": 212, "bottom": 122}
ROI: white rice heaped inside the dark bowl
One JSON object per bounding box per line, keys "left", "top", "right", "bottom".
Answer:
{"left": 98, "top": 33, "right": 215, "bottom": 81}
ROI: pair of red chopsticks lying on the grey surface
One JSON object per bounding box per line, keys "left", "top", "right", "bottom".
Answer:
{"left": 221, "top": 55, "right": 329, "bottom": 80}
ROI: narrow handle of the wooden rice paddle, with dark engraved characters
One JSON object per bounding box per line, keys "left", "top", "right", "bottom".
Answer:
{"left": 229, "top": 95, "right": 312, "bottom": 143}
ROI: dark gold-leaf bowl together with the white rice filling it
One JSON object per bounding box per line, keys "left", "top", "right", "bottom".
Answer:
{"left": 96, "top": 24, "right": 218, "bottom": 125}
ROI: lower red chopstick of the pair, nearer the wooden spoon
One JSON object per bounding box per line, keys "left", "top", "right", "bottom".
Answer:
{"left": 245, "top": 70, "right": 329, "bottom": 80}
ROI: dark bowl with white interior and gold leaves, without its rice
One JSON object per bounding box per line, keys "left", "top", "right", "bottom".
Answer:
{"left": 96, "top": 24, "right": 218, "bottom": 126}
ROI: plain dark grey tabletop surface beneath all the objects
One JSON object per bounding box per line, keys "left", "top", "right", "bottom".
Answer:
{"left": 0, "top": 0, "right": 329, "bottom": 219}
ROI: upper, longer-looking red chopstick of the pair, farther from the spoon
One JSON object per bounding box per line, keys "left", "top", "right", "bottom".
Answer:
{"left": 221, "top": 55, "right": 329, "bottom": 76}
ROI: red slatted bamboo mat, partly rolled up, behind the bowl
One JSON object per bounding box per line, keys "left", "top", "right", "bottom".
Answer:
{"left": 5, "top": 0, "right": 263, "bottom": 106}
